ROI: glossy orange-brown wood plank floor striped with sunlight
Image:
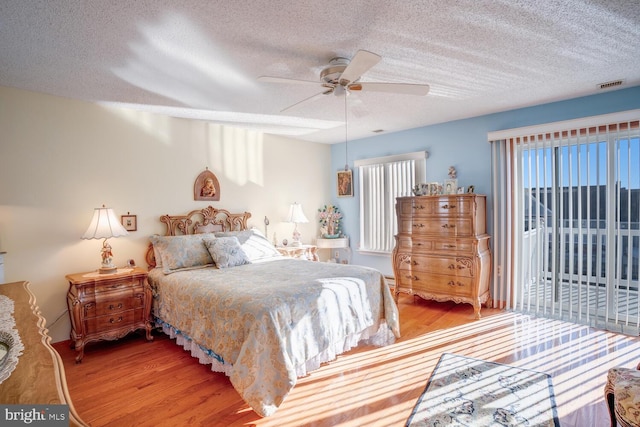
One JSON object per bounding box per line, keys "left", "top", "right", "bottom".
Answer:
{"left": 54, "top": 295, "right": 640, "bottom": 427}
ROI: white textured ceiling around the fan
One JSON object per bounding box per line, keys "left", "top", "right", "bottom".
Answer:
{"left": 0, "top": 0, "right": 640, "bottom": 143}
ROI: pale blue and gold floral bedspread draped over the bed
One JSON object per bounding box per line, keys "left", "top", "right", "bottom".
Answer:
{"left": 149, "top": 258, "right": 400, "bottom": 416}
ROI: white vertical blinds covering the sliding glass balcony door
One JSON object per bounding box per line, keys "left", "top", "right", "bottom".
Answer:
{"left": 489, "top": 110, "right": 640, "bottom": 335}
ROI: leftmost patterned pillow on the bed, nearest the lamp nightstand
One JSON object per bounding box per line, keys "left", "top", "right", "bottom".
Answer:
{"left": 150, "top": 234, "right": 213, "bottom": 274}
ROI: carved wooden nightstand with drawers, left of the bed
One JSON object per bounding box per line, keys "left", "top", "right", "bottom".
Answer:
{"left": 66, "top": 268, "right": 153, "bottom": 363}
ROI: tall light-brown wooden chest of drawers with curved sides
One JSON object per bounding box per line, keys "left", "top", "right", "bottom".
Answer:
{"left": 393, "top": 194, "right": 491, "bottom": 319}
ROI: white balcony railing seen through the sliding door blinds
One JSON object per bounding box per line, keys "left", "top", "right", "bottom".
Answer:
{"left": 516, "top": 221, "right": 640, "bottom": 335}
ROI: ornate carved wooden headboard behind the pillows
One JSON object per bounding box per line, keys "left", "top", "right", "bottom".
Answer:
{"left": 145, "top": 206, "right": 251, "bottom": 269}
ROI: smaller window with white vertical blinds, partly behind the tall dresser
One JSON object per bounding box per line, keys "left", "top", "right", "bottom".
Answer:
{"left": 355, "top": 151, "right": 427, "bottom": 254}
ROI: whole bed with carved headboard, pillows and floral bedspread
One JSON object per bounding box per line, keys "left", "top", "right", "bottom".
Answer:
{"left": 146, "top": 206, "right": 400, "bottom": 417}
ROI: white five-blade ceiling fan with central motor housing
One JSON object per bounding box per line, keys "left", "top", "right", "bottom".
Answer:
{"left": 258, "top": 50, "right": 429, "bottom": 112}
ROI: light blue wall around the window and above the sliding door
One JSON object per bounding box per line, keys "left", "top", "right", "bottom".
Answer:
{"left": 331, "top": 86, "right": 640, "bottom": 275}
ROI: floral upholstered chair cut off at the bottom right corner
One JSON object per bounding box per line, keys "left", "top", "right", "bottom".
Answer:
{"left": 604, "top": 364, "right": 640, "bottom": 427}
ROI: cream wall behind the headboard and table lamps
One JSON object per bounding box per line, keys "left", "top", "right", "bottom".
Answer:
{"left": 0, "top": 87, "right": 332, "bottom": 342}
